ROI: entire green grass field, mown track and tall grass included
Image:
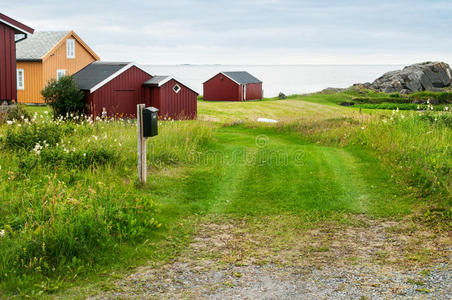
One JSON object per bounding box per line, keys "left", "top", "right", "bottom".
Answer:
{"left": 0, "top": 94, "right": 452, "bottom": 298}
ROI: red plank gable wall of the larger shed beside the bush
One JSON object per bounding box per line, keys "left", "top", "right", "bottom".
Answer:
{"left": 85, "top": 66, "right": 152, "bottom": 117}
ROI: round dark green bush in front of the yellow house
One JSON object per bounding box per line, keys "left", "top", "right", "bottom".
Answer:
{"left": 41, "top": 76, "right": 85, "bottom": 118}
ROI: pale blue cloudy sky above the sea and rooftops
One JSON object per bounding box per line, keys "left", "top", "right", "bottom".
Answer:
{"left": 0, "top": 0, "right": 452, "bottom": 65}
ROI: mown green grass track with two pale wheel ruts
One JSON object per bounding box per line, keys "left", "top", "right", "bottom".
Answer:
{"left": 159, "top": 126, "right": 409, "bottom": 220}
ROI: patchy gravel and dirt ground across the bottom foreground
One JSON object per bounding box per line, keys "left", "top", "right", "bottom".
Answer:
{"left": 90, "top": 216, "right": 452, "bottom": 299}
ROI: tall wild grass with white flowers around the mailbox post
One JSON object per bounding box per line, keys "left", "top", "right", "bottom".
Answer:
{"left": 0, "top": 114, "right": 213, "bottom": 292}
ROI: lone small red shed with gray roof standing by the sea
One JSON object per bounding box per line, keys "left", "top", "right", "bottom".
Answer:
{"left": 203, "top": 71, "right": 263, "bottom": 101}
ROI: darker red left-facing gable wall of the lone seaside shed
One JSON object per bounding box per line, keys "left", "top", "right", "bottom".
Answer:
{"left": 203, "top": 73, "right": 243, "bottom": 101}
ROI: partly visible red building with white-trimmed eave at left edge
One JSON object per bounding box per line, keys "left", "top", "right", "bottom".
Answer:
{"left": 0, "top": 13, "right": 34, "bottom": 104}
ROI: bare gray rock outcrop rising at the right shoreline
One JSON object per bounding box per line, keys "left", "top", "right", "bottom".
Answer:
{"left": 364, "top": 62, "right": 452, "bottom": 94}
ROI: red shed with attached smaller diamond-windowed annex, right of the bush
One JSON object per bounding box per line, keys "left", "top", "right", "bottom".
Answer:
{"left": 74, "top": 62, "right": 197, "bottom": 119}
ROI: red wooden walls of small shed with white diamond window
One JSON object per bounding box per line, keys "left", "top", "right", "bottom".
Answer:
{"left": 149, "top": 79, "right": 198, "bottom": 120}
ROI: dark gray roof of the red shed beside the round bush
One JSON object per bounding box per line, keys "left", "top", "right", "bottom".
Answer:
{"left": 74, "top": 61, "right": 130, "bottom": 90}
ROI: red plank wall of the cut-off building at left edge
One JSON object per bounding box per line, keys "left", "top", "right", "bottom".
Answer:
{"left": 0, "top": 23, "right": 16, "bottom": 104}
